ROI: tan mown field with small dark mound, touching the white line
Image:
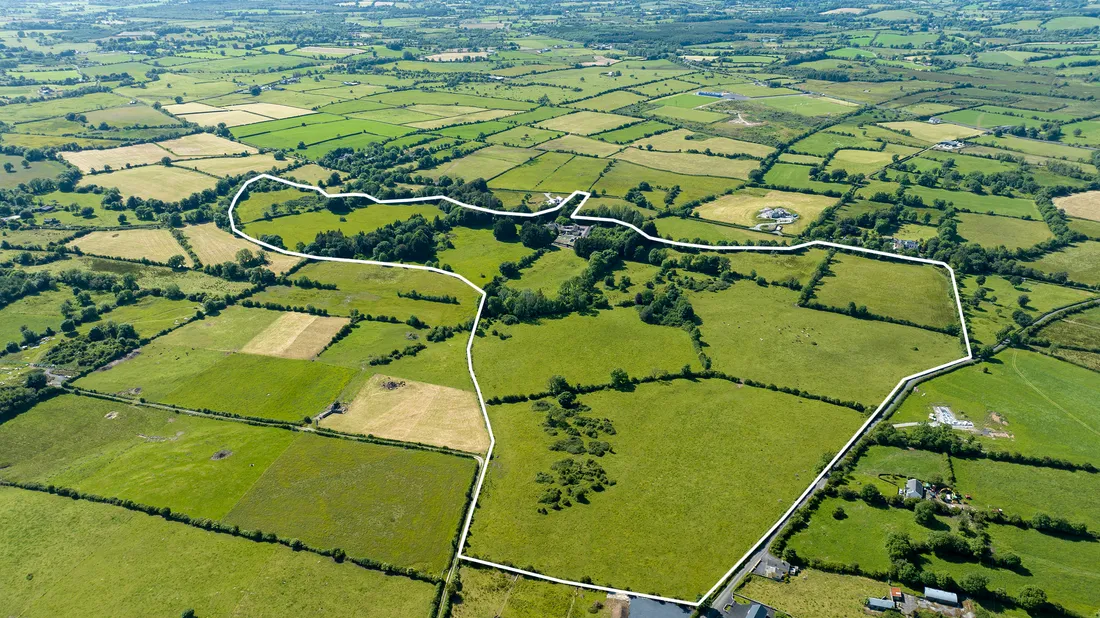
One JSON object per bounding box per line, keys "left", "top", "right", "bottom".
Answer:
{"left": 321, "top": 375, "right": 488, "bottom": 453}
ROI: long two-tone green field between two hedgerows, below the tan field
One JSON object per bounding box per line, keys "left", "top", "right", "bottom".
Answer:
{"left": 0, "top": 395, "right": 473, "bottom": 573}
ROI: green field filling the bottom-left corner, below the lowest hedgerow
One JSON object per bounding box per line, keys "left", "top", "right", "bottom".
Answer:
{"left": 0, "top": 487, "right": 435, "bottom": 618}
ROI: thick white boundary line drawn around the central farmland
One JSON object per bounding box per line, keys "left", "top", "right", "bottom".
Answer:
{"left": 229, "top": 174, "right": 974, "bottom": 607}
